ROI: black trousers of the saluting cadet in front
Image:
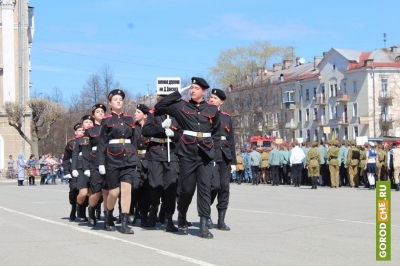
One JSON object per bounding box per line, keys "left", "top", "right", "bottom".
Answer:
{"left": 178, "top": 157, "right": 214, "bottom": 218}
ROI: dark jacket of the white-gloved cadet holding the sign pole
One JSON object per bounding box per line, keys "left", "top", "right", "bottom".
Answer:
{"left": 142, "top": 109, "right": 182, "bottom": 162}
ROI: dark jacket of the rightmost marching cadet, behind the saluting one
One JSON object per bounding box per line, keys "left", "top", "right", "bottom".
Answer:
{"left": 215, "top": 111, "right": 236, "bottom": 165}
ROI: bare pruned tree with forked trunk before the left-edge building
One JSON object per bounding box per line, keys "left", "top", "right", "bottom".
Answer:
{"left": 4, "top": 99, "right": 66, "bottom": 156}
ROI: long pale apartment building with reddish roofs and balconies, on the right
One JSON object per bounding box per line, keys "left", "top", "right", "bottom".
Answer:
{"left": 229, "top": 47, "right": 400, "bottom": 145}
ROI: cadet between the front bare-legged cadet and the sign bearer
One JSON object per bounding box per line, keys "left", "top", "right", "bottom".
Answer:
{"left": 129, "top": 104, "right": 152, "bottom": 227}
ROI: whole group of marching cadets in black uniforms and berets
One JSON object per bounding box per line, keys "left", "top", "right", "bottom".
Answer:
{"left": 63, "top": 77, "right": 236, "bottom": 239}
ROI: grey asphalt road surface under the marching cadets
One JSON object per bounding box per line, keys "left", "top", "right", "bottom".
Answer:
{"left": 0, "top": 181, "right": 400, "bottom": 266}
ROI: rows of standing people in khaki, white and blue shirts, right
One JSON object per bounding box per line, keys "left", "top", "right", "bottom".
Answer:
{"left": 235, "top": 140, "right": 400, "bottom": 191}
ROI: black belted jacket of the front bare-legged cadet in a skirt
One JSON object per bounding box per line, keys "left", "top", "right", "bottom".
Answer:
{"left": 96, "top": 112, "right": 141, "bottom": 170}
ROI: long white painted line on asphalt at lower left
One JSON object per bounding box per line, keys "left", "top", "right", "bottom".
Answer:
{"left": 0, "top": 206, "right": 216, "bottom": 266}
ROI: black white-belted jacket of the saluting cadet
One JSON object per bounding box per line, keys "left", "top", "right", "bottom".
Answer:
{"left": 155, "top": 92, "right": 221, "bottom": 160}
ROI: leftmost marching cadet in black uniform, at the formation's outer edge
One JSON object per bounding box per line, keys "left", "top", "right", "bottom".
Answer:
{"left": 63, "top": 123, "right": 84, "bottom": 221}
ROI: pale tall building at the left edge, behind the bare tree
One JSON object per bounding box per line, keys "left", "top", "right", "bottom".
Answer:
{"left": 0, "top": 0, "right": 34, "bottom": 169}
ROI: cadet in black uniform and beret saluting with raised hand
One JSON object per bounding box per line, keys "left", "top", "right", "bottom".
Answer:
{"left": 155, "top": 77, "right": 220, "bottom": 238}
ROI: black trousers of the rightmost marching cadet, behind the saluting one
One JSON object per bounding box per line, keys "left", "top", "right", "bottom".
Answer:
{"left": 211, "top": 160, "right": 231, "bottom": 210}
